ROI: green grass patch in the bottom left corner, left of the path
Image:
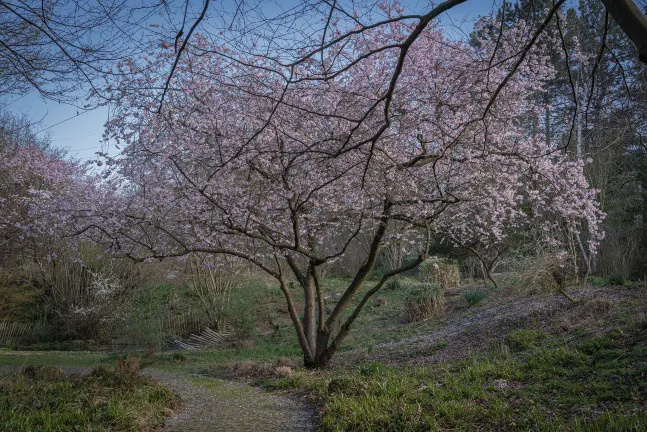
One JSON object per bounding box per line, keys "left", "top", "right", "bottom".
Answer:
{"left": 0, "top": 366, "right": 179, "bottom": 432}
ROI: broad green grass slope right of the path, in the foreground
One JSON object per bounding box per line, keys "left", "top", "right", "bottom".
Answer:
{"left": 259, "top": 330, "right": 647, "bottom": 431}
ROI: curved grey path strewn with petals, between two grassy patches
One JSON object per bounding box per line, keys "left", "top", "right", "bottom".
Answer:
{"left": 143, "top": 369, "right": 316, "bottom": 432}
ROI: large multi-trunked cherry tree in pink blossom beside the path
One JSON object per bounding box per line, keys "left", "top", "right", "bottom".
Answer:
{"left": 33, "top": 2, "right": 602, "bottom": 367}
